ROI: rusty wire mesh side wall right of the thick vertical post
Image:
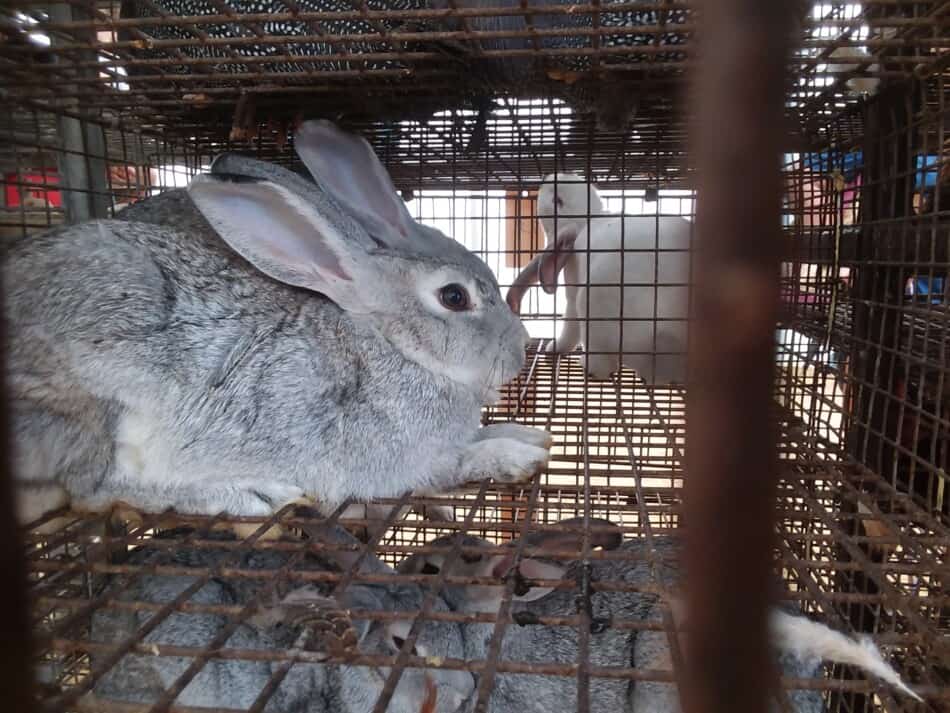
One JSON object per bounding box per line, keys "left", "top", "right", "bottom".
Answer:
{"left": 786, "top": 73, "right": 950, "bottom": 522}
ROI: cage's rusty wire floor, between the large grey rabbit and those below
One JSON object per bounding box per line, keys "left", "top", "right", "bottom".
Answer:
{"left": 26, "top": 343, "right": 950, "bottom": 711}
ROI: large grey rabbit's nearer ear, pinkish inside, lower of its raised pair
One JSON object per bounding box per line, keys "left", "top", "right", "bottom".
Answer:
{"left": 188, "top": 175, "right": 370, "bottom": 312}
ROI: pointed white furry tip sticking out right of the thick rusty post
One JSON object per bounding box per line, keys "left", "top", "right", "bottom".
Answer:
{"left": 771, "top": 610, "right": 923, "bottom": 701}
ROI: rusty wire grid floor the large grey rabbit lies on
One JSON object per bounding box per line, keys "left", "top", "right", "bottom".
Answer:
{"left": 18, "top": 344, "right": 950, "bottom": 711}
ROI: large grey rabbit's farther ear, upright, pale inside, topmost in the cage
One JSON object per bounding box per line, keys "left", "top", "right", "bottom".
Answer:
{"left": 294, "top": 120, "right": 415, "bottom": 247}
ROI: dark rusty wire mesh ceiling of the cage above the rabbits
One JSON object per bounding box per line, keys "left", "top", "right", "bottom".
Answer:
{"left": 0, "top": 0, "right": 947, "bottom": 142}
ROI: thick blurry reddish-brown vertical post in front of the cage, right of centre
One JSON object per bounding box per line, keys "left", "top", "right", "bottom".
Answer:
{"left": 681, "top": 0, "right": 795, "bottom": 713}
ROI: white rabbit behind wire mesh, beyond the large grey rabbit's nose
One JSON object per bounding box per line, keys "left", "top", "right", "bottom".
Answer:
{"left": 506, "top": 174, "right": 691, "bottom": 384}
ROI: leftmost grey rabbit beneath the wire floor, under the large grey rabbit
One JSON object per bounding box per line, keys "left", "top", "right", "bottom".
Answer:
{"left": 91, "top": 529, "right": 474, "bottom": 713}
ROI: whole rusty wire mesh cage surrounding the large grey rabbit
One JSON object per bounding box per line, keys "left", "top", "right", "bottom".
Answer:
{"left": 0, "top": 0, "right": 950, "bottom": 712}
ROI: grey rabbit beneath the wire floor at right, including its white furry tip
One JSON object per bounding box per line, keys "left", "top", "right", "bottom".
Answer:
{"left": 397, "top": 519, "right": 920, "bottom": 713}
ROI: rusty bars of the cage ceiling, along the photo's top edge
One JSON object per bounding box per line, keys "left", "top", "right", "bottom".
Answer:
{"left": 0, "top": 0, "right": 948, "bottom": 136}
